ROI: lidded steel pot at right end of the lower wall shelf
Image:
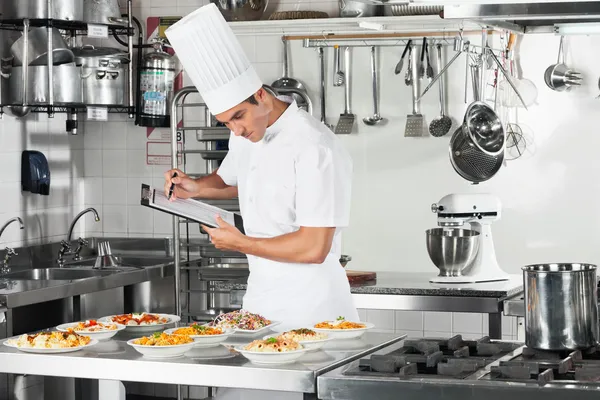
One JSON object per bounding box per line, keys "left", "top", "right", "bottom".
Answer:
{"left": 73, "top": 45, "right": 129, "bottom": 105}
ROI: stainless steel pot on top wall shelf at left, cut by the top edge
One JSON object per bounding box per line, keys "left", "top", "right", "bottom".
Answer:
{"left": 0, "top": 0, "right": 83, "bottom": 21}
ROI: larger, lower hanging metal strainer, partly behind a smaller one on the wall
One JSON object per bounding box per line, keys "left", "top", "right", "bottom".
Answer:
{"left": 449, "top": 127, "right": 504, "bottom": 183}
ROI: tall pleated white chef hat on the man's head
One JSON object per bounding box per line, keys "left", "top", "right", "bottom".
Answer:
{"left": 165, "top": 3, "right": 262, "bottom": 114}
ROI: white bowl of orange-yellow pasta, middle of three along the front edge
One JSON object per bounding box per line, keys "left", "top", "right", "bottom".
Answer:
{"left": 127, "top": 332, "right": 195, "bottom": 358}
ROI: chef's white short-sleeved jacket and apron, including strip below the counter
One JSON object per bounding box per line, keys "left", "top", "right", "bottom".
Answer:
{"left": 217, "top": 98, "right": 358, "bottom": 400}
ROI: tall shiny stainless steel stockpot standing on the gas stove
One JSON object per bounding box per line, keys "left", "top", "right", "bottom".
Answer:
{"left": 523, "top": 264, "right": 598, "bottom": 350}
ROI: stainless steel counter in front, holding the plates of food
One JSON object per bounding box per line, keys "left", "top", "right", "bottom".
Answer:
{"left": 0, "top": 332, "right": 405, "bottom": 393}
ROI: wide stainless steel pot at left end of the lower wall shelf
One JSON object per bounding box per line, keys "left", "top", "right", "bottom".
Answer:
{"left": 1, "top": 64, "right": 82, "bottom": 105}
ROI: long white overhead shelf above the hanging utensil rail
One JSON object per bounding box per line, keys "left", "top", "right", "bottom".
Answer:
{"left": 229, "top": 15, "right": 481, "bottom": 36}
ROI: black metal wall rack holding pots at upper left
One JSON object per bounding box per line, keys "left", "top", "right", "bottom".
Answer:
{"left": 0, "top": 0, "right": 135, "bottom": 118}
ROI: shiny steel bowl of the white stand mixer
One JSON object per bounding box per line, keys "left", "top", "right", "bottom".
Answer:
{"left": 426, "top": 228, "right": 479, "bottom": 276}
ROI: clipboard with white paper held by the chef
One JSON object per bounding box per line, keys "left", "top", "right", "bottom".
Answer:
{"left": 140, "top": 184, "right": 245, "bottom": 233}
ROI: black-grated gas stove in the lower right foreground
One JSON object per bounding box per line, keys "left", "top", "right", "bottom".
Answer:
{"left": 317, "top": 335, "right": 600, "bottom": 400}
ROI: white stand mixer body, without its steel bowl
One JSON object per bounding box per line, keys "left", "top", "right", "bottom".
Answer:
{"left": 430, "top": 193, "right": 509, "bottom": 283}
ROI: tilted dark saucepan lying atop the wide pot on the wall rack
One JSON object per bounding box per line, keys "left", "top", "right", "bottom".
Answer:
{"left": 10, "top": 28, "right": 74, "bottom": 67}
